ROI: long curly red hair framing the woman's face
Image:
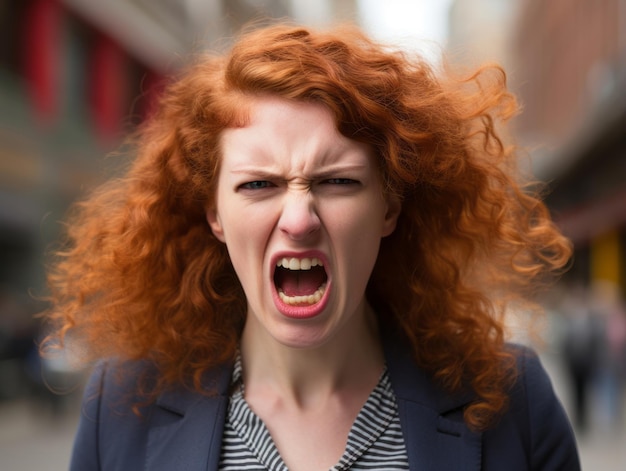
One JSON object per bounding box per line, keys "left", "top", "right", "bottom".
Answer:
{"left": 42, "top": 25, "right": 570, "bottom": 429}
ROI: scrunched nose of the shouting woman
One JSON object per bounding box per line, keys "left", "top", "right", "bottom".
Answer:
{"left": 278, "top": 191, "right": 321, "bottom": 241}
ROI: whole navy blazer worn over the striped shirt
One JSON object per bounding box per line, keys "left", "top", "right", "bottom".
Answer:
{"left": 70, "top": 342, "right": 580, "bottom": 471}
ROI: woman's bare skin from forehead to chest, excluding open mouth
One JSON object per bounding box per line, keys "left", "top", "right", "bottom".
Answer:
{"left": 207, "top": 98, "right": 400, "bottom": 469}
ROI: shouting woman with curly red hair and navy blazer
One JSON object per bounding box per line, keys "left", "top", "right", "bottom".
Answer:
{"left": 42, "top": 25, "right": 579, "bottom": 470}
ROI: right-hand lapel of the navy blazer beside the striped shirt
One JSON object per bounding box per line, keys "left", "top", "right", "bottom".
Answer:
{"left": 384, "top": 338, "right": 482, "bottom": 471}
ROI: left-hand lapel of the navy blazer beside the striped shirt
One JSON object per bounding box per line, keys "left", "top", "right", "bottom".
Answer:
{"left": 146, "top": 365, "right": 231, "bottom": 471}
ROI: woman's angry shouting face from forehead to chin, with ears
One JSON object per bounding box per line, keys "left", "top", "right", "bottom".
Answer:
{"left": 207, "top": 97, "right": 400, "bottom": 347}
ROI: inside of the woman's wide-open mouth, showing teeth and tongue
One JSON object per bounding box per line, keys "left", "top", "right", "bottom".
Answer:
{"left": 274, "top": 257, "right": 328, "bottom": 306}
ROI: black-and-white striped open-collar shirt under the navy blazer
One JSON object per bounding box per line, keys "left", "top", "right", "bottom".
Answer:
{"left": 219, "top": 358, "right": 409, "bottom": 471}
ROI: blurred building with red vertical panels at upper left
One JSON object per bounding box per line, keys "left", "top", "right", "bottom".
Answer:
{"left": 0, "top": 0, "right": 358, "bottom": 398}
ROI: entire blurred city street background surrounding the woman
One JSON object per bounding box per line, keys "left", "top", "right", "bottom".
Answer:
{"left": 0, "top": 0, "right": 626, "bottom": 471}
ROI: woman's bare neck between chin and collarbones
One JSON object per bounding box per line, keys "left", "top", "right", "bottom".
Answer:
{"left": 241, "top": 303, "right": 384, "bottom": 407}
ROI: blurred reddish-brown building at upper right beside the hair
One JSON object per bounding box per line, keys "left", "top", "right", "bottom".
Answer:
{"left": 449, "top": 0, "right": 626, "bottom": 292}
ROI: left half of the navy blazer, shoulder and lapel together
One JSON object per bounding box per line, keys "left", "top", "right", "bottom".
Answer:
{"left": 70, "top": 360, "right": 230, "bottom": 471}
